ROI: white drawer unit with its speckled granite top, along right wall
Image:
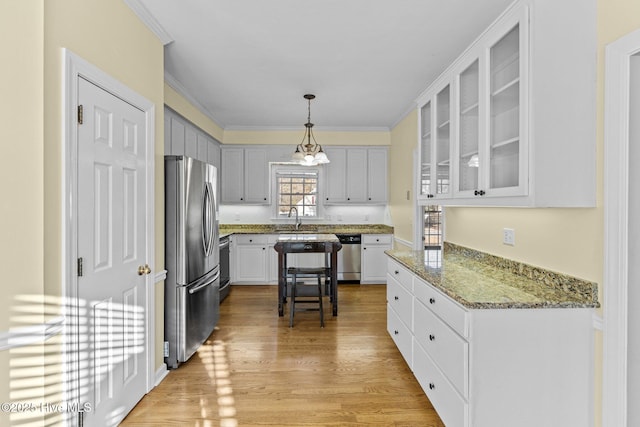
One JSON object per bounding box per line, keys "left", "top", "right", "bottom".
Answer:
{"left": 387, "top": 243, "right": 599, "bottom": 427}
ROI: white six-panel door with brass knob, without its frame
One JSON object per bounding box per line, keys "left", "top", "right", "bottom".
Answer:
{"left": 77, "top": 78, "right": 150, "bottom": 426}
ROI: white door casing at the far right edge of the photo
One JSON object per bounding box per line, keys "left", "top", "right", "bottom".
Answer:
{"left": 602, "top": 30, "right": 640, "bottom": 427}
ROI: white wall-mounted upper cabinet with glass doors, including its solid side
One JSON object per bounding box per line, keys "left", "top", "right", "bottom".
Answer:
{"left": 416, "top": 0, "right": 596, "bottom": 207}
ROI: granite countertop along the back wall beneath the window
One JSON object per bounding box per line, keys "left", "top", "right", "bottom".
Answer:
{"left": 219, "top": 223, "right": 393, "bottom": 237}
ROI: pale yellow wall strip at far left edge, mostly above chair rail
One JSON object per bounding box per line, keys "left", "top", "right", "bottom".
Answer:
{"left": 0, "top": 0, "right": 45, "bottom": 425}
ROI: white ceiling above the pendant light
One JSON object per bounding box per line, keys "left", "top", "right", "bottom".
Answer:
{"left": 132, "top": 0, "right": 512, "bottom": 130}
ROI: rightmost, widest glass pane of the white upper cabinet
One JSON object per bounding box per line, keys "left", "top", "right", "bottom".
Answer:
{"left": 489, "top": 26, "right": 520, "bottom": 188}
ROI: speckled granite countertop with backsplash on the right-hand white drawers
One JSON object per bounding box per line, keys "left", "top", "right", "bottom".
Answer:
{"left": 386, "top": 243, "right": 600, "bottom": 309}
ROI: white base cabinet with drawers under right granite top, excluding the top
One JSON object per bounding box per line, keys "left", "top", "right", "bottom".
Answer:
{"left": 387, "top": 259, "right": 594, "bottom": 427}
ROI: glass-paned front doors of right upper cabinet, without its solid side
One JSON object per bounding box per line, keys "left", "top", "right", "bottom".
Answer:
{"left": 419, "top": 7, "right": 528, "bottom": 204}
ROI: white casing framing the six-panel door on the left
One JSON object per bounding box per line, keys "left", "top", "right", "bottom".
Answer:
{"left": 60, "top": 49, "right": 157, "bottom": 425}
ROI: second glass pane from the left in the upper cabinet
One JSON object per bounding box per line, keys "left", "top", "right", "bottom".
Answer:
{"left": 435, "top": 85, "right": 451, "bottom": 194}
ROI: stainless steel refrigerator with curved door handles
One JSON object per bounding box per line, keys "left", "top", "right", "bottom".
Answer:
{"left": 164, "top": 156, "right": 220, "bottom": 369}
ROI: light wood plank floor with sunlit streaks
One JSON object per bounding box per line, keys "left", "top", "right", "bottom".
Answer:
{"left": 122, "top": 284, "right": 444, "bottom": 427}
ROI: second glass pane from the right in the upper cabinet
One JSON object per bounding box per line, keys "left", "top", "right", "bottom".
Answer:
{"left": 458, "top": 59, "right": 480, "bottom": 191}
